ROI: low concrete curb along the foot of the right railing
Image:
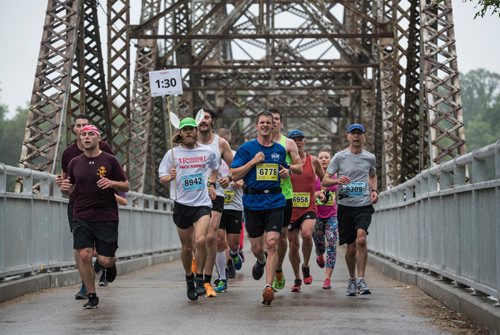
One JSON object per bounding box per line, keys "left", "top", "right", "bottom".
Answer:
{"left": 369, "top": 253, "right": 500, "bottom": 334}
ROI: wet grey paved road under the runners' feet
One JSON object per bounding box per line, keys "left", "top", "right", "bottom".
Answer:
{"left": 0, "top": 249, "right": 452, "bottom": 335}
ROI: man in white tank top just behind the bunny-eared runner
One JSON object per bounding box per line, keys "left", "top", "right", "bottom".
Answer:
{"left": 196, "top": 109, "right": 233, "bottom": 298}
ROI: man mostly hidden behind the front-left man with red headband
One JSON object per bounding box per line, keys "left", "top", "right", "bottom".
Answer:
{"left": 56, "top": 115, "right": 114, "bottom": 300}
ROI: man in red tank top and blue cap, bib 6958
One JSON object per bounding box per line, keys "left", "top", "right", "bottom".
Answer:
{"left": 288, "top": 129, "right": 325, "bottom": 292}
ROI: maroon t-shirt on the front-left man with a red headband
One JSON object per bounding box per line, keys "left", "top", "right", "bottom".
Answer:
{"left": 68, "top": 152, "right": 127, "bottom": 221}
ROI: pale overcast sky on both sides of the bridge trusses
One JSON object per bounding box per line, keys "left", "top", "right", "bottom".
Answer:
{"left": 0, "top": 0, "right": 500, "bottom": 117}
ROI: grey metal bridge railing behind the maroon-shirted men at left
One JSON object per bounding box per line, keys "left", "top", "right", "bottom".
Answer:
{"left": 0, "top": 164, "right": 180, "bottom": 281}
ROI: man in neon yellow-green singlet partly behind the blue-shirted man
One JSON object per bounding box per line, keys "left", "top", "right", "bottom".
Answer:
{"left": 269, "top": 108, "right": 302, "bottom": 290}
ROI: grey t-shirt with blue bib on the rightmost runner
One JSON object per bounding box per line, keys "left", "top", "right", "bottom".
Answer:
{"left": 326, "top": 148, "right": 376, "bottom": 207}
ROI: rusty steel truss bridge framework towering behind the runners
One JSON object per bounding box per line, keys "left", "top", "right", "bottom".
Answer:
{"left": 20, "top": 0, "right": 465, "bottom": 195}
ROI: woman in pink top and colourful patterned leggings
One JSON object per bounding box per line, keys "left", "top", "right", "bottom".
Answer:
{"left": 313, "top": 150, "right": 338, "bottom": 290}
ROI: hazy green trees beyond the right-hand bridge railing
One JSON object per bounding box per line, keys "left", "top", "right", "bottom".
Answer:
{"left": 460, "top": 69, "right": 500, "bottom": 152}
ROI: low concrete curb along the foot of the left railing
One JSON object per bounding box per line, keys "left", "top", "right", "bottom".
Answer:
{"left": 0, "top": 250, "right": 180, "bottom": 303}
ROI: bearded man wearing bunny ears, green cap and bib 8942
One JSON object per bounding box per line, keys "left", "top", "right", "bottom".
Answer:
{"left": 158, "top": 117, "right": 219, "bottom": 300}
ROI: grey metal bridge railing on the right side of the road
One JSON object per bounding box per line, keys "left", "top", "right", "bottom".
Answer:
{"left": 369, "top": 140, "right": 500, "bottom": 303}
